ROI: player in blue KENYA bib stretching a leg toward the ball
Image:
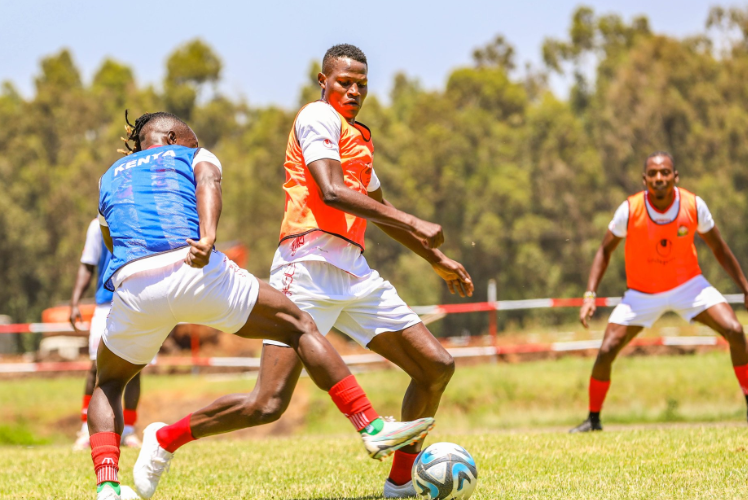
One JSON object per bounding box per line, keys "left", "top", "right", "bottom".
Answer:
{"left": 88, "top": 112, "right": 433, "bottom": 500}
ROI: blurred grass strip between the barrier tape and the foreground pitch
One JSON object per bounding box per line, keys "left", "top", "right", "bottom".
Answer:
{"left": 0, "top": 352, "right": 745, "bottom": 444}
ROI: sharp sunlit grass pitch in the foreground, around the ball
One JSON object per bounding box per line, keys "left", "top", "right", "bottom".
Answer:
{"left": 0, "top": 427, "right": 748, "bottom": 500}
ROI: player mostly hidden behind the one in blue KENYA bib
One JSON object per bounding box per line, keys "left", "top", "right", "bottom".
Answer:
{"left": 70, "top": 219, "right": 141, "bottom": 450}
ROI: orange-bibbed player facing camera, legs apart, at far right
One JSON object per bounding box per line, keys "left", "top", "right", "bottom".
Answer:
{"left": 571, "top": 152, "right": 748, "bottom": 432}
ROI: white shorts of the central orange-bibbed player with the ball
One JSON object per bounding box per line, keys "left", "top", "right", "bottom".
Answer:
{"left": 264, "top": 261, "right": 421, "bottom": 347}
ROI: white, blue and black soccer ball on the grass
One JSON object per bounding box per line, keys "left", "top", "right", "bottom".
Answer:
{"left": 412, "top": 443, "right": 478, "bottom": 500}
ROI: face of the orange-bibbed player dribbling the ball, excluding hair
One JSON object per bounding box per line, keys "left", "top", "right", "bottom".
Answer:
{"left": 319, "top": 57, "right": 369, "bottom": 121}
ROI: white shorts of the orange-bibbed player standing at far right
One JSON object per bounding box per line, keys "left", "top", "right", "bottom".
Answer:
{"left": 608, "top": 275, "right": 727, "bottom": 328}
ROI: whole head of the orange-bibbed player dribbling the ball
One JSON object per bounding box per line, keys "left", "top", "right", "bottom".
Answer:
{"left": 317, "top": 43, "right": 369, "bottom": 120}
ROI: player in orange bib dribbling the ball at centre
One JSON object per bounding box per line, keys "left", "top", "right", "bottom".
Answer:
{"left": 226, "top": 44, "right": 473, "bottom": 498}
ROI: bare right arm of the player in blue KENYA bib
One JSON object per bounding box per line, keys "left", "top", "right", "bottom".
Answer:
{"left": 184, "top": 161, "right": 223, "bottom": 268}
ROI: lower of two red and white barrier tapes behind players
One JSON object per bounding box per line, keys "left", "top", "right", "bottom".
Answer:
{"left": 0, "top": 336, "right": 727, "bottom": 373}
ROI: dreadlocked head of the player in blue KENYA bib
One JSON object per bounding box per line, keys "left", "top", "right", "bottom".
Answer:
{"left": 119, "top": 111, "right": 198, "bottom": 155}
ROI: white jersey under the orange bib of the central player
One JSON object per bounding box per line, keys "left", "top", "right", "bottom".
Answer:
{"left": 270, "top": 101, "right": 381, "bottom": 277}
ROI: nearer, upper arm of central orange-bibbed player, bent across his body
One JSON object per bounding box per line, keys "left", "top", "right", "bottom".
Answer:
{"left": 308, "top": 158, "right": 444, "bottom": 248}
